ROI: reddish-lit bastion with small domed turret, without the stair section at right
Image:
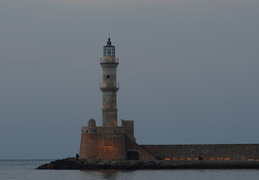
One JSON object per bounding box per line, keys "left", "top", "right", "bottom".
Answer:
{"left": 79, "top": 119, "right": 126, "bottom": 160}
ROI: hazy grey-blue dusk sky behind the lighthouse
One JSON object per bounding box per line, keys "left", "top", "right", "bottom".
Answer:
{"left": 0, "top": 0, "right": 259, "bottom": 159}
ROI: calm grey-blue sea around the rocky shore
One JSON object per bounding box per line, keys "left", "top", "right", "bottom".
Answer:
{"left": 0, "top": 160, "right": 259, "bottom": 180}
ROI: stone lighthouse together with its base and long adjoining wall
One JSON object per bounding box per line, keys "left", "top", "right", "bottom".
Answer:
{"left": 79, "top": 38, "right": 259, "bottom": 162}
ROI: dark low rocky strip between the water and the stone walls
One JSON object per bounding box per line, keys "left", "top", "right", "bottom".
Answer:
{"left": 36, "top": 158, "right": 259, "bottom": 170}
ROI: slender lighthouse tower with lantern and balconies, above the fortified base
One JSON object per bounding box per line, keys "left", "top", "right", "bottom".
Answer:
{"left": 100, "top": 38, "right": 119, "bottom": 127}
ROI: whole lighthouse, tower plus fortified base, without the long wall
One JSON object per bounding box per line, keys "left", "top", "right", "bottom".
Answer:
{"left": 79, "top": 38, "right": 154, "bottom": 161}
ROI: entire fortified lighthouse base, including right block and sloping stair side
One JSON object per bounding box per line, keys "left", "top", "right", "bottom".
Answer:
{"left": 79, "top": 119, "right": 155, "bottom": 161}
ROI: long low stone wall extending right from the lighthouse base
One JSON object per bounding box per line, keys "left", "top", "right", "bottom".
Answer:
{"left": 140, "top": 144, "right": 259, "bottom": 160}
